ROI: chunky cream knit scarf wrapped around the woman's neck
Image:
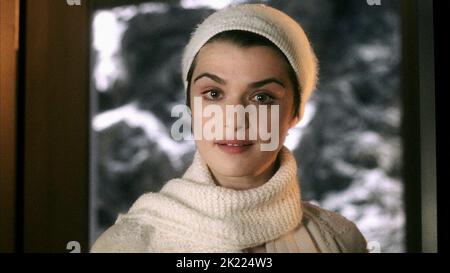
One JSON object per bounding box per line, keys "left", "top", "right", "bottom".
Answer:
{"left": 116, "top": 146, "right": 302, "bottom": 252}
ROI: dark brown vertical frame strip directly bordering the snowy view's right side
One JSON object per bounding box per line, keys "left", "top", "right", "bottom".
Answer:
{"left": 402, "top": 0, "right": 422, "bottom": 252}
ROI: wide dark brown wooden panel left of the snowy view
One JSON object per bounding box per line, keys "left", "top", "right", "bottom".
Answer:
{"left": 24, "top": 0, "right": 89, "bottom": 252}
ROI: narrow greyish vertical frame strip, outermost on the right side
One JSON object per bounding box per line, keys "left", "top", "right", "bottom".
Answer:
{"left": 417, "top": 0, "right": 437, "bottom": 252}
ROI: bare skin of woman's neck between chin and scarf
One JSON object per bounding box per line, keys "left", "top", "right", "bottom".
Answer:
{"left": 210, "top": 158, "right": 279, "bottom": 190}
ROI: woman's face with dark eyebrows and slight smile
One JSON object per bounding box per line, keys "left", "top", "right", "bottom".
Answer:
{"left": 190, "top": 41, "right": 298, "bottom": 178}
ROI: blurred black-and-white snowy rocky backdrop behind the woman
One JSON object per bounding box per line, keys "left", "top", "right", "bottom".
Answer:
{"left": 90, "top": 0, "right": 405, "bottom": 252}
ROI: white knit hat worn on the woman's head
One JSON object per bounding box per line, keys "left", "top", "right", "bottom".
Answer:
{"left": 182, "top": 4, "right": 318, "bottom": 115}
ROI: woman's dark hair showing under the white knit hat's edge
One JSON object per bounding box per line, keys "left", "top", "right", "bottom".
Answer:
{"left": 186, "top": 30, "right": 300, "bottom": 117}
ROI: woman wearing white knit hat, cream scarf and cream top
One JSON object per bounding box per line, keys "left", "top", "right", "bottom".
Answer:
{"left": 91, "top": 4, "right": 367, "bottom": 252}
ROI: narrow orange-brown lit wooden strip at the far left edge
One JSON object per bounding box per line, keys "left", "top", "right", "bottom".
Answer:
{"left": 0, "top": 0, "right": 19, "bottom": 252}
